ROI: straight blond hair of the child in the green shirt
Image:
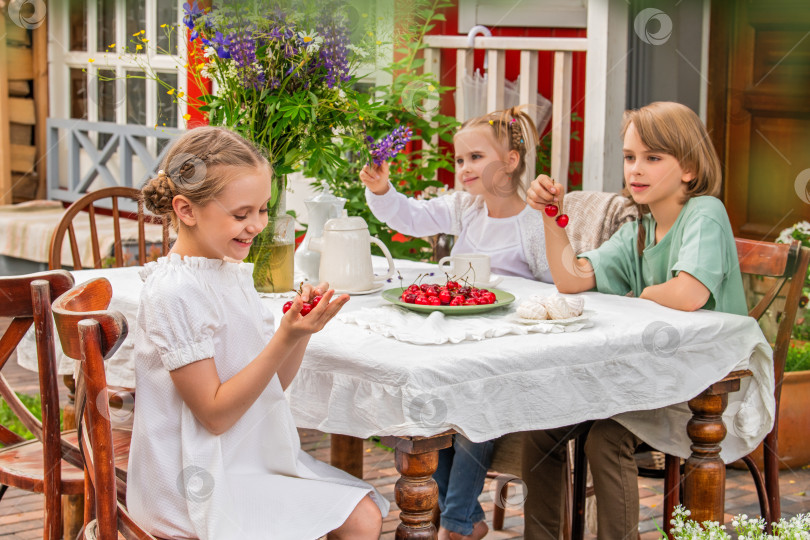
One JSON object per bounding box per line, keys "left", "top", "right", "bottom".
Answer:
{"left": 622, "top": 101, "right": 722, "bottom": 256}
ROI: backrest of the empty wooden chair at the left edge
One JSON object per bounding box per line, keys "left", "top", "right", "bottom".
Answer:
{"left": 0, "top": 270, "right": 77, "bottom": 523}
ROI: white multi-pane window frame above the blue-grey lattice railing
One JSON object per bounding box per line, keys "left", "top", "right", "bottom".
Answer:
{"left": 48, "top": 0, "right": 188, "bottom": 136}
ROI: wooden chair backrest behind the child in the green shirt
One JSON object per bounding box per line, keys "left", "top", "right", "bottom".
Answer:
{"left": 735, "top": 238, "right": 810, "bottom": 411}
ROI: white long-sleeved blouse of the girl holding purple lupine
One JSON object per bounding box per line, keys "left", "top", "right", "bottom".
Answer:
{"left": 366, "top": 184, "right": 552, "bottom": 283}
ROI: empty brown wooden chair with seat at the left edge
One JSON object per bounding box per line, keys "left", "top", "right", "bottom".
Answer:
{"left": 0, "top": 270, "right": 84, "bottom": 539}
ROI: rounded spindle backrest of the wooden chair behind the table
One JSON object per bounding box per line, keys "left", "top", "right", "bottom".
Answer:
{"left": 48, "top": 186, "right": 169, "bottom": 270}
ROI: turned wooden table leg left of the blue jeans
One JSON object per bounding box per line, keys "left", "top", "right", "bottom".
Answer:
{"left": 383, "top": 433, "right": 453, "bottom": 540}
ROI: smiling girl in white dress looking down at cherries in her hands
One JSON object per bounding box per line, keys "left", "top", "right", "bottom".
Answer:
{"left": 127, "top": 127, "right": 388, "bottom": 540}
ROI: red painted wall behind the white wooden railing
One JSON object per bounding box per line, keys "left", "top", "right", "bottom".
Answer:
{"left": 430, "top": 6, "right": 586, "bottom": 186}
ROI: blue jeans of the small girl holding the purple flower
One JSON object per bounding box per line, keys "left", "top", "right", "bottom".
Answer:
{"left": 433, "top": 435, "right": 495, "bottom": 536}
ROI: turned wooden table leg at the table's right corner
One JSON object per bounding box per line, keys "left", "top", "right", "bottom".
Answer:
{"left": 683, "top": 372, "right": 750, "bottom": 523}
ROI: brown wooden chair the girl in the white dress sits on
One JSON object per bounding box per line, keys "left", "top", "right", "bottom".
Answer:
{"left": 53, "top": 278, "right": 154, "bottom": 540}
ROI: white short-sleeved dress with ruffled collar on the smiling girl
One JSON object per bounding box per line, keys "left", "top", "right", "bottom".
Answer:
{"left": 127, "top": 255, "right": 389, "bottom": 540}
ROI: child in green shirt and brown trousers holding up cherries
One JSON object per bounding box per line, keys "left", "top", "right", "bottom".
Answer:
{"left": 523, "top": 102, "right": 748, "bottom": 540}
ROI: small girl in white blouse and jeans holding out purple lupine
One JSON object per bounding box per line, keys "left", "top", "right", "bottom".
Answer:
{"left": 360, "top": 107, "right": 552, "bottom": 540}
